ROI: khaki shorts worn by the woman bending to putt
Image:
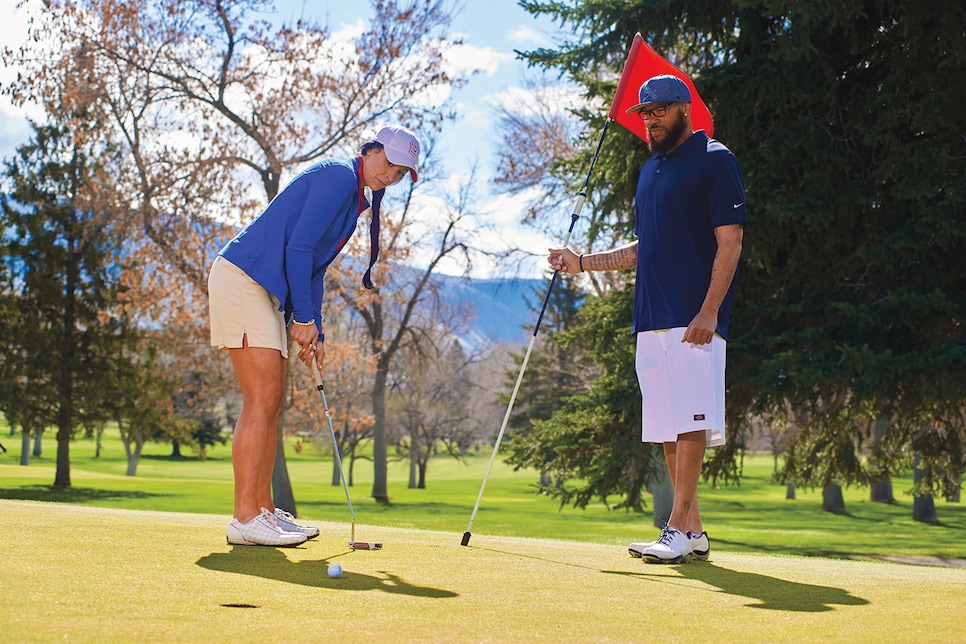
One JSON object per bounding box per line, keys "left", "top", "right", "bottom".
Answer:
{"left": 208, "top": 255, "right": 288, "bottom": 358}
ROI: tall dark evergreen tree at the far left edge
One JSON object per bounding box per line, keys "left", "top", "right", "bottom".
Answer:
{"left": 0, "top": 124, "right": 142, "bottom": 487}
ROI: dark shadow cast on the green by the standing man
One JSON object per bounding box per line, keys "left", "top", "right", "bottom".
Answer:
{"left": 648, "top": 562, "right": 869, "bottom": 613}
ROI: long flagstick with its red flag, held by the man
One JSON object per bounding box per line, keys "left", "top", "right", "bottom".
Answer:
{"left": 458, "top": 33, "right": 714, "bottom": 546}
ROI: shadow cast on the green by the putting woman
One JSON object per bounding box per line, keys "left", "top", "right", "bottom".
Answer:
{"left": 196, "top": 546, "right": 458, "bottom": 599}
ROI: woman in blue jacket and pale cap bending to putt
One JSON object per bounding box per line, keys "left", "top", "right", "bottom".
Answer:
{"left": 208, "top": 126, "right": 419, "bottom": 546}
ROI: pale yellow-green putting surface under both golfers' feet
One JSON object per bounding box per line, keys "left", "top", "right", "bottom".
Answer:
{"left": 0, "top": 500, "right": 966, "bottom": 642}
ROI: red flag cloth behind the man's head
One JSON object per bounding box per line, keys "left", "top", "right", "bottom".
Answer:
{"left": 607, "top": 33, "right": 714, "bottom": 143}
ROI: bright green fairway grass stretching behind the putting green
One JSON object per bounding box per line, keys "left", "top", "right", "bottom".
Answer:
{"left": 0, "top": 434, "right": 966, "bottom": 559}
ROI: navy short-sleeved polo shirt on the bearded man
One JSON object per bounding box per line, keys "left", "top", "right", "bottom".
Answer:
{"left": 634, "top": 130, "right": 748, "bottom": 339}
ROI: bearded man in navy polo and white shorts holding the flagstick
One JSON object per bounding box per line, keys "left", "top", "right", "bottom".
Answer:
{"left": 548, "top": 75, "right": 747, "bottom": 563}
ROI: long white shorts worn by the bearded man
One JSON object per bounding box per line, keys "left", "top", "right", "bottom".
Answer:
{"left": 637, "top": 327, "right": 727, "bottom": 447}
